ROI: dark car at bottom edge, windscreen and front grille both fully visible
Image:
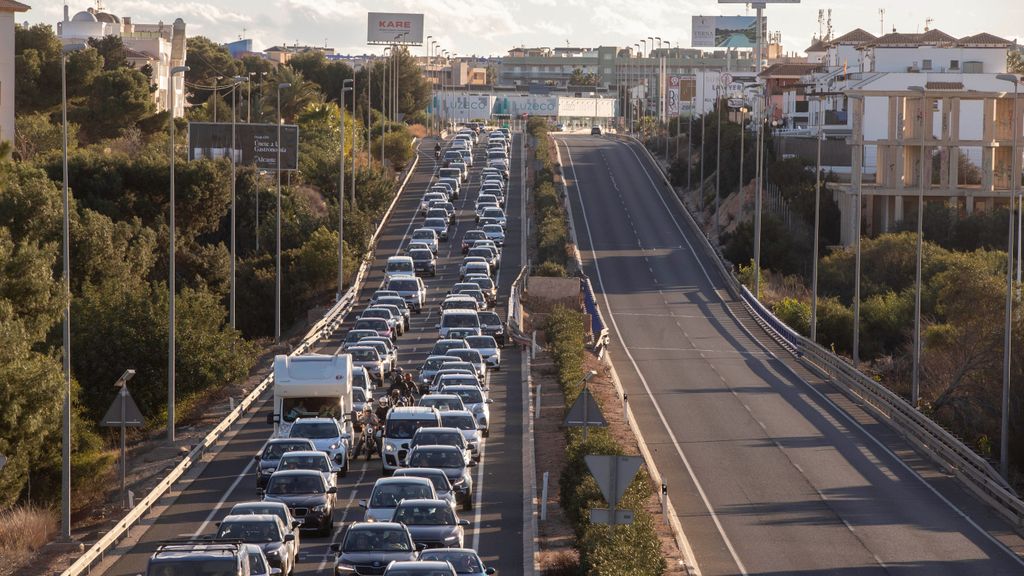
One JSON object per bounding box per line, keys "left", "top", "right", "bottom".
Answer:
{"left": 331, "top": 522, "right": 425, "bottom": 576}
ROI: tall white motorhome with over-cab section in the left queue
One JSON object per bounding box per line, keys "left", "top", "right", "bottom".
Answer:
{"left": 267, "top": 354, "right": 352, "bottom": 437}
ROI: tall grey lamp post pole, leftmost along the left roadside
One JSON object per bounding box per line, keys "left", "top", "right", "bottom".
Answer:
{"left": 60, "top": 48, "right": 72, "bottom": 540}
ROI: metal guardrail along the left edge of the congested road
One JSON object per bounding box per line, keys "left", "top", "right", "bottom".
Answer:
{"left": 60, "top": 141, "right": 420, "bottom": 576}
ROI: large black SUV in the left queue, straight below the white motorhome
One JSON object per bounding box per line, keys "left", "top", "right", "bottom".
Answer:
{"left": 261, "top": 470, "right": 337, "bottom": 536}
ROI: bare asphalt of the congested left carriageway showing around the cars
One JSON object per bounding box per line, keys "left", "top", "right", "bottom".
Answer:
{"left": 103, "top": 134, "right": 527, "bottom": 576}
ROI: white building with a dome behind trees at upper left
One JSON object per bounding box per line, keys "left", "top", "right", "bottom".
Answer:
{"left": 58, "top": 5, "right": 185, "bottom": 117}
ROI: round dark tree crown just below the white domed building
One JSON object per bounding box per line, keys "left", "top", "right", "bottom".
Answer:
{"left": 74, "top": 68, "right": 156, "bottom": 139}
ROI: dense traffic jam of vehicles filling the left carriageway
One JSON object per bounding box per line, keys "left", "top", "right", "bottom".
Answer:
{"left": 147, "top": 124, "right": 512, "bottom": 576}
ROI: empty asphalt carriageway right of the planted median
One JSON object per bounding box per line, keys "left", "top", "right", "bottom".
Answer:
{"left": 559, "top": 136, "right": 1024, "bottom": 576}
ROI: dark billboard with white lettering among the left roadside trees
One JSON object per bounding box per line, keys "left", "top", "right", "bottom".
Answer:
{"left": 188, "top": 122, "right": 299, "bottom": 170}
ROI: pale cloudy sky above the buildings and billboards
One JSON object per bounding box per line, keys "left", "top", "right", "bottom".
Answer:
{"left": 18, "top": 0, "right": 1024, "bottom": 56}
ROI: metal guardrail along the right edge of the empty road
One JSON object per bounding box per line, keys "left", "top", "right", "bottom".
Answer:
{"left": 627, "top": 132, "right": 1024, "bottom": 529}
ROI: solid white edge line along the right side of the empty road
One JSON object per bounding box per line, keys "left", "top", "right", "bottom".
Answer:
{"left": 614, "top": 138, "right": 1024, "bottom": 566}
